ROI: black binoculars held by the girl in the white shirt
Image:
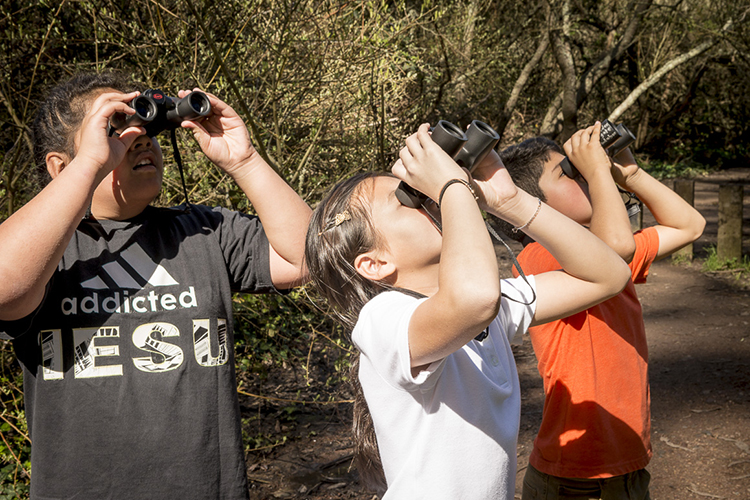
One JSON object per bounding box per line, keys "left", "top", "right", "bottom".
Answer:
{"left": 396, "top": 120, "right": 500, "bottom": 208}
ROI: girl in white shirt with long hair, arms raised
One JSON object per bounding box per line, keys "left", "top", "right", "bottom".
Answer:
{"left": 306, "top": 124, "right": 630, "bottom": 500}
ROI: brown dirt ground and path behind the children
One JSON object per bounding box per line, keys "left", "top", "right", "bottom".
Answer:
{"left": 243, "top": 169, "right": 750, "bottom": 500}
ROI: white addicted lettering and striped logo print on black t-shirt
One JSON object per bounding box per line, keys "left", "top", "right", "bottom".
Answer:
{"left": 39, "top": 237, "right": 230, "bottom": 380}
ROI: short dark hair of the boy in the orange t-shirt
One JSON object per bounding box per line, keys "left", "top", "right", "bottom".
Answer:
{"left": 497, "top": 137, "right": 565, "bottom": 241}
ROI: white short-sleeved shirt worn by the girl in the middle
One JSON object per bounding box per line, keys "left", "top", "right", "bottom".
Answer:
{"left": 352, "top": 276, "right": 536, "bottom": 500}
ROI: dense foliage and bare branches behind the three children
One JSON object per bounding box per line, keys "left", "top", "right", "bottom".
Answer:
{"left": 0, "top": 0, "right": 750, "bottom": 492}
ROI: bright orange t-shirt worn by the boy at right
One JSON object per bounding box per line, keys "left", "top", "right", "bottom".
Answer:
{"left": 518, "top": 228, "right": 659, "bottom": 479}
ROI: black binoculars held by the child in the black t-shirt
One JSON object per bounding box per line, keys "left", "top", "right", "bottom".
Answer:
{"left": 109, "top": 89, "right": 211, "bottom": 137}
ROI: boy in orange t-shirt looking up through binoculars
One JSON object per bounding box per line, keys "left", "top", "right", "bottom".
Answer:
{"left": 500, "top": 122, "right": 705, "bottom": 500}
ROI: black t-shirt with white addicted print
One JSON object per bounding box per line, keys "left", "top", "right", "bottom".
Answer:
{"left": 0, "top": 206, "right": 274, "bottom": 500}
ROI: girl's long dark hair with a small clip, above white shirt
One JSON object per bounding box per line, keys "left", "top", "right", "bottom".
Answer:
{"left": 305, "top": 172, "right": 389, "bottom": 491}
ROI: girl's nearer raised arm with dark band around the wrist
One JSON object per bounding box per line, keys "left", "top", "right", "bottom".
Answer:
{"left": 393, "top": 125, "right": 500, "bottom": 368}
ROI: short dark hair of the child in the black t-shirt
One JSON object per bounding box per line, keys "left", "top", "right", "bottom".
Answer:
{"left": 32, "top": 71, "right": 142, "bottom": 185}
